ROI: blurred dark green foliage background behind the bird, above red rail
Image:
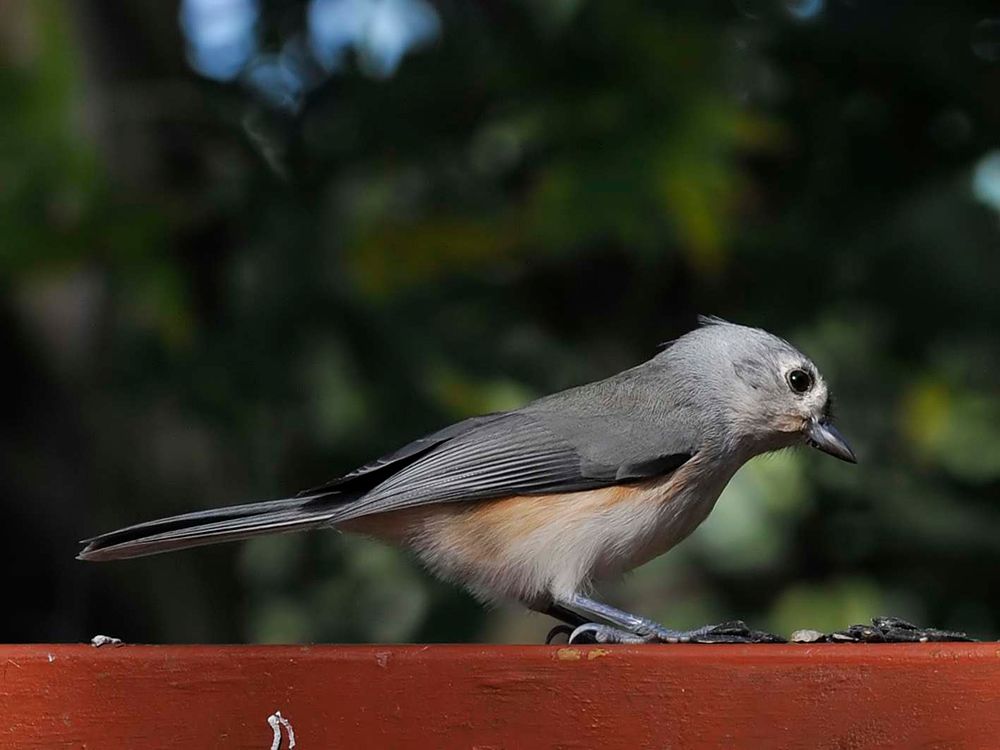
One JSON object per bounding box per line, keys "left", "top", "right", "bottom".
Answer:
{"left": 0, "top": 0, "right": 1000, "bottom": 642}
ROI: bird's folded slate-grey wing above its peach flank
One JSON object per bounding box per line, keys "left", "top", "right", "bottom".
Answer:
{"left": 326, "top": 368, "right": 694, "bottom": 523}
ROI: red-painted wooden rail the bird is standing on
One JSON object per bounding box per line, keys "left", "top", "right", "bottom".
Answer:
{"left": 0, "top": 643, "right": 1000, "bottom": 750}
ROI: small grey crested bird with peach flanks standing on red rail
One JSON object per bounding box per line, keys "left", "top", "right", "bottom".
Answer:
{"left": 78, "top": 317, "right": 857, "bottom": 643}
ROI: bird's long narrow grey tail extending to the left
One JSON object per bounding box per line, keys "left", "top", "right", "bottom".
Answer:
{"left": 77, "top": 492, "right": 336, "bottom": 560}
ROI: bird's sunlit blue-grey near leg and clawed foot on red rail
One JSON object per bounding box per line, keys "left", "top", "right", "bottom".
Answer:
{"left": 554, "top": 594, "right": 784, "bottom": 643}
